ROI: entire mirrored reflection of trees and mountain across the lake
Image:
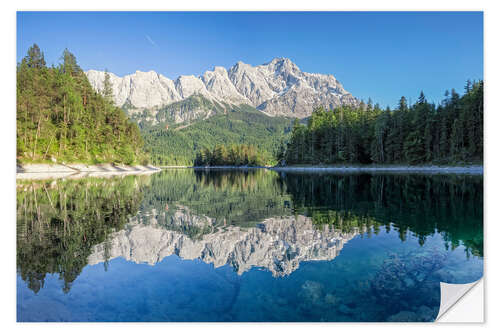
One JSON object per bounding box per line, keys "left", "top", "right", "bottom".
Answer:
{"left": 17, "top": 170, "right": 483, "bottom": 292}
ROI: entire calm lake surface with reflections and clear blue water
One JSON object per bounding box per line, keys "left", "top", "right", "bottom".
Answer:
{"left": 17, "top": 169, "right": 483, "bottom": 321}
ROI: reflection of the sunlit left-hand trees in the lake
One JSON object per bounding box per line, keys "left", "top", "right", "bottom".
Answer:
{"left": 17, "top": 176, "right": 148, "bottom": 292}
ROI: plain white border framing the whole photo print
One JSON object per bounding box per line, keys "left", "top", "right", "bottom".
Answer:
{"left": 0, "top": 0, "right": 500, "bottom": 333}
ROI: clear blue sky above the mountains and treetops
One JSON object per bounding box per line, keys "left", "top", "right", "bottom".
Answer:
{"left": 17, "top": 12, "right": 483, "bottom": 107}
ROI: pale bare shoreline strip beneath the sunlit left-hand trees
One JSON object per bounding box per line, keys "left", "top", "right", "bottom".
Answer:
{"left": 16, "top": 163, "right": 161, "bottom": 180}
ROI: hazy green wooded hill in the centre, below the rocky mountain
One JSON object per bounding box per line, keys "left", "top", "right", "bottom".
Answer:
{"left": 141, "top": 105, "right": 292, "bottom": 165}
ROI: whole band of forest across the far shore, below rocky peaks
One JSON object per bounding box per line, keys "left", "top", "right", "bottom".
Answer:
{"left": 17, "top": 44, "right": 483, "bottom": 166}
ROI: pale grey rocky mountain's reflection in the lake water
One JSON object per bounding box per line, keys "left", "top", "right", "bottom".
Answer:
{"left": 88, "top": 210, "right": 358, "bottom": 276}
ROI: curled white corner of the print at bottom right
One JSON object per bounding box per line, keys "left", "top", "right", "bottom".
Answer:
{"left": 436, "top": 279, "right": 484, "bottom": 323}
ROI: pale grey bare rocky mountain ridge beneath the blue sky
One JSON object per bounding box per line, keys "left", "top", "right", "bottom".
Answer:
{"left": 86, "top": 58, "right": 358, "bottom": 123}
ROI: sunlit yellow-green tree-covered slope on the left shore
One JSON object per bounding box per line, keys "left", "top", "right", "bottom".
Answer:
{"left": 17, "top": 44, "right": 148, "bottom": 164}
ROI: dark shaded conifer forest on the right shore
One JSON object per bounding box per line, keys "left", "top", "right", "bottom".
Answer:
{"left": 278, "top": 81, "right": 483, "bottom": 164}
